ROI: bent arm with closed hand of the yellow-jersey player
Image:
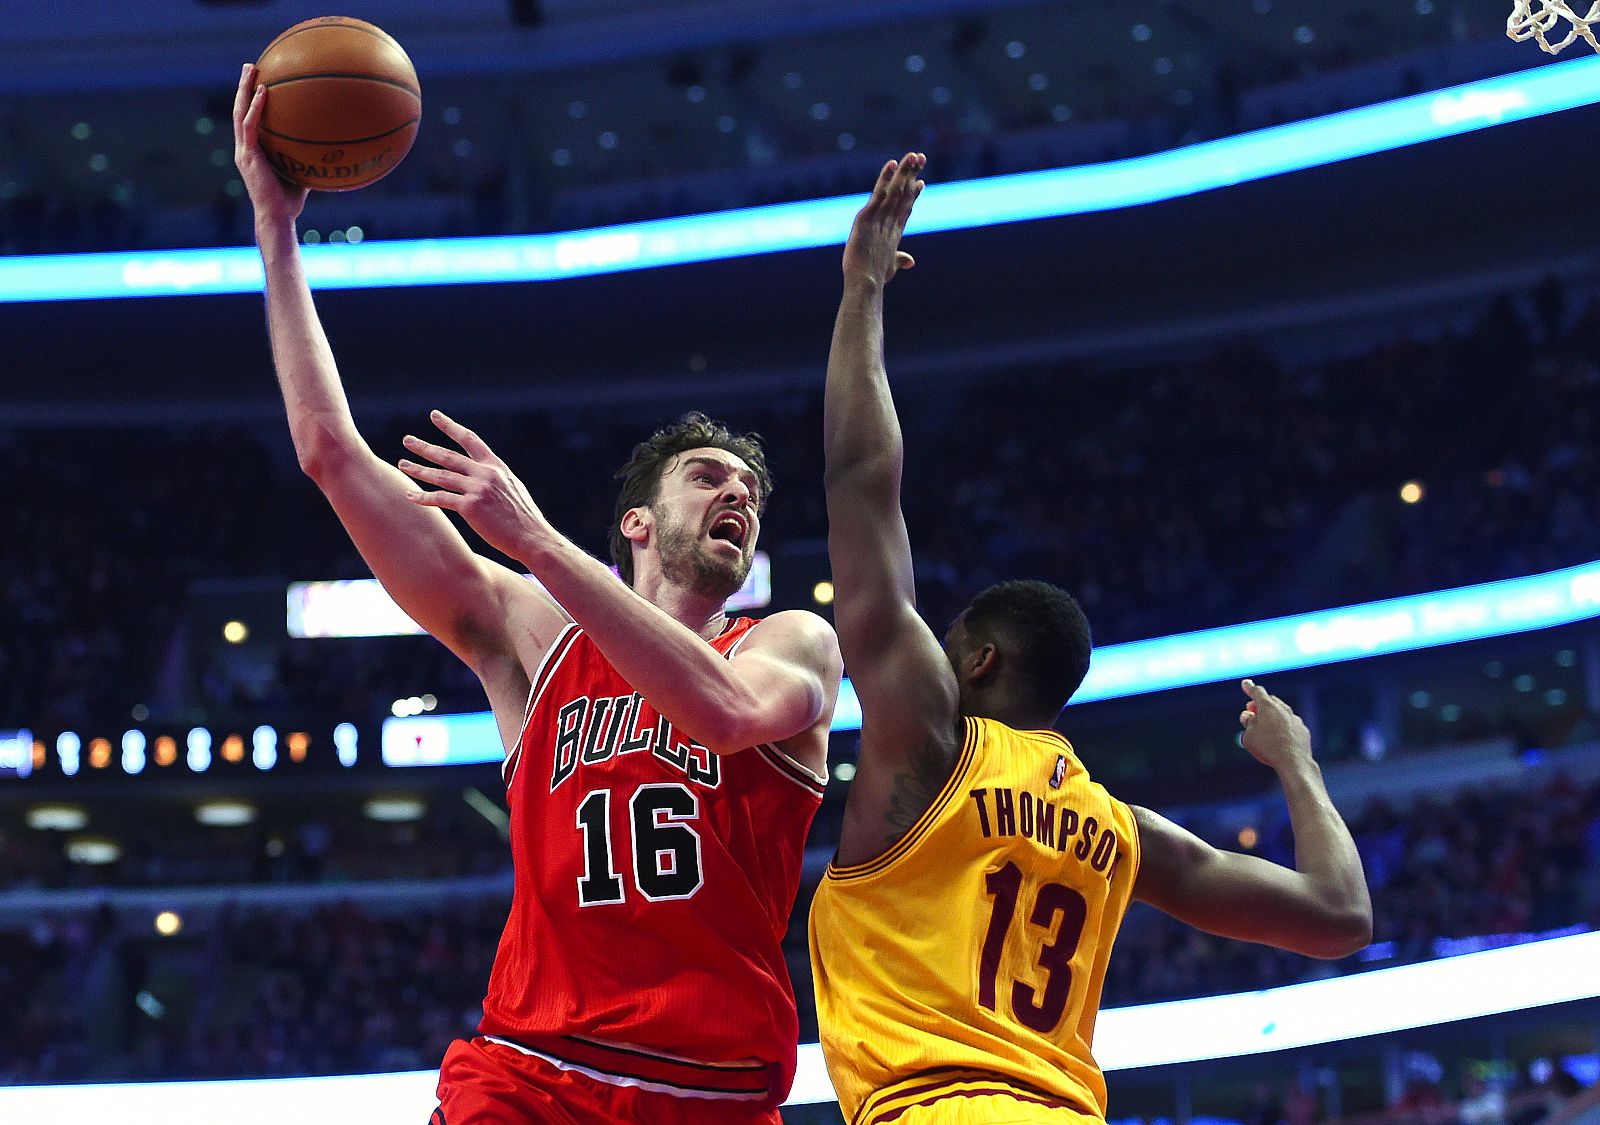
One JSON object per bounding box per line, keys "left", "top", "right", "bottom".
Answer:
{"left": 1133, "top": 680, "right": 1373, "bottom": 959}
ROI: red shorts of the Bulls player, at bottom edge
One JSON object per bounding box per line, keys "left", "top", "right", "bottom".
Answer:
{"left": 429, "top": 1035, "right": 782, "bottom": 1125}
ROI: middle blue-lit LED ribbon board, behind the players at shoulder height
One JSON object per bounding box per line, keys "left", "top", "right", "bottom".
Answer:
{"left": 382, "top": 562, "right": 1600, "bottom": 767}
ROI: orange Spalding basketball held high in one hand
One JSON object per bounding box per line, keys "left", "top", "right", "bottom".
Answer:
{"left": 256, "top": 16, "right": 422, "bottom": 192}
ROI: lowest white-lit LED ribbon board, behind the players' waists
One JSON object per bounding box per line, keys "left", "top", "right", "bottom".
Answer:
{"left": 0, "top": 933, "right": 1600, "bottom": 1125}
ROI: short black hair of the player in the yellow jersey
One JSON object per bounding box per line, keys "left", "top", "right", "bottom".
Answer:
{"left": 965, "top": 579, "right": 1093, "bottom": 717}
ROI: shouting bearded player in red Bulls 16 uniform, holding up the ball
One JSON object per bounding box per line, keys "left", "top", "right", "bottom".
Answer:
{"left": 234, "top": 67, "right": 842, "bottom": 1125}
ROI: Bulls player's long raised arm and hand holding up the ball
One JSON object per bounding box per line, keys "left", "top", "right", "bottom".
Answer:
{"left": 234, "top": 66, "right": 562, "bottom": 729}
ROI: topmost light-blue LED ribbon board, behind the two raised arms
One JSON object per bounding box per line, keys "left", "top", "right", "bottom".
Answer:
{"left": 0, "top": 58, "right": 1600, "bottom": 302}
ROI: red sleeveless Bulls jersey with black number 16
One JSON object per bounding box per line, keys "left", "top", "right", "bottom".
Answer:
{"left": 480, "top": 618, "right": 826, "bottom": 1104}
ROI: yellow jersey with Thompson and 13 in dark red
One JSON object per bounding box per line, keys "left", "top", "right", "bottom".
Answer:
{"left": 811, "top": 719, "right": 1139, "bottom": 1125}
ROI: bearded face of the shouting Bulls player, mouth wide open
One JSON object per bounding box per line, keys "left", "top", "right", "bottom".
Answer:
{"left": 650, "top": 448, "right": 762, "bottom": 599}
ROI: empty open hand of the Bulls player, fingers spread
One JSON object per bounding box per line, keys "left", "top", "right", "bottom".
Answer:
{"left": 400, "top": 410, "right": 549, "bottom": 558}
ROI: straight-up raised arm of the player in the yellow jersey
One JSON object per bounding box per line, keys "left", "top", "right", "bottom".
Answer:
{"left": 822, "top": 152, "right": 960, "bottom": 861}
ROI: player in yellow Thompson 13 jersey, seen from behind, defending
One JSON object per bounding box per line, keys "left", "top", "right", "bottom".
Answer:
{"left": 811, "top": 154, "right": 1371, "bottom": 1125}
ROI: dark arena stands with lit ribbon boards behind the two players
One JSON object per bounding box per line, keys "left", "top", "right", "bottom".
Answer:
{"left": 0, "top": 0, "right": 1600, "bottom": 1125}
